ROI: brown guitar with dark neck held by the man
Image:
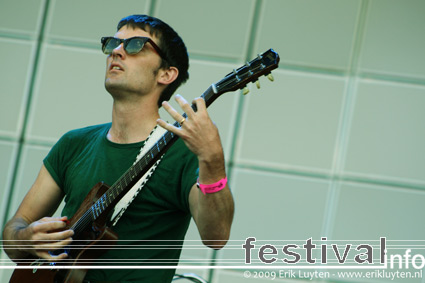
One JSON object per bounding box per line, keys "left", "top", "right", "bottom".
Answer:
{"left": 10, "top": 49, "right": 279, "bottom": 283}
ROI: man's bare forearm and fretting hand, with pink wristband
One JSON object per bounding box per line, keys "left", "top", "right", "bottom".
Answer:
{"left": 158, "top": 95, "right": 234, "bottom": 249}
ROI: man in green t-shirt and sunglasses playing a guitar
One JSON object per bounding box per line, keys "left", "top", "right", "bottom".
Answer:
{"left": 3, "top": 15, "right": 234, "bottom": 283}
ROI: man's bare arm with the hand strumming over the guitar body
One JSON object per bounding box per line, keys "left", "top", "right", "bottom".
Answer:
{"left": 3, "top": 165, "right": 74, "bottom": 260}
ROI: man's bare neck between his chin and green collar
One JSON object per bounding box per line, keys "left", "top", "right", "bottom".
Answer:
{"left": 107, "top": 97, "right": 159, "bottom": 144}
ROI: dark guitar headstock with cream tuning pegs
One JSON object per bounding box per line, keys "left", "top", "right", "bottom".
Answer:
{"left": 215, "top": 49, "right": 280, "bottom": 95}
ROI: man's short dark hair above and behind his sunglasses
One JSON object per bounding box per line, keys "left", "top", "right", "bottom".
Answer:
{"left": 117, "top": 15, "right": 189, "bottom": 107}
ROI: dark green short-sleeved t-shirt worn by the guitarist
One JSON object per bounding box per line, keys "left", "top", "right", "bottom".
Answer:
{"left": 44, "top": 123, "right": 198, "bottom": 283}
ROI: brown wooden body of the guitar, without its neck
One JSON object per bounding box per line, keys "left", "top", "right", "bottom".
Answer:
{"left": 10, "top": 182, "right": 118, "bottom": 283}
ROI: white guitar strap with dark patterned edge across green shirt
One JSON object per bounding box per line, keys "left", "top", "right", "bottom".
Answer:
{"left": 111, "top": 126, "right": 166, "bottom": 226}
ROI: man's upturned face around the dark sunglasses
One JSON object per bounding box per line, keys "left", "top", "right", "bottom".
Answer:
{"left": 105, "top": 26, "right": 161, "bottom": 99}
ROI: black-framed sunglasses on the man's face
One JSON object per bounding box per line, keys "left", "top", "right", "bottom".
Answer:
{"left": 101, "top": 36, "right": 168, "bottom": 61}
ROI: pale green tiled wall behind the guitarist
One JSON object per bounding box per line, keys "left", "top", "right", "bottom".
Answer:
{"left": 0, "top": 0, "right": 425, "bottom": 282}
